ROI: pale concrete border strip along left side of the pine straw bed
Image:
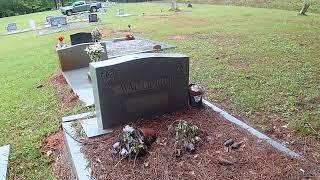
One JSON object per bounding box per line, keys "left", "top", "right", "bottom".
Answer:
{"left": 62, "top": 122, "right": 94, "bottom": 180}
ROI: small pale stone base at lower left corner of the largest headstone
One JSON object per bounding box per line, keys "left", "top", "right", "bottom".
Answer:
{"left": 80, "top": 118, "right": 113, "bottom": 138}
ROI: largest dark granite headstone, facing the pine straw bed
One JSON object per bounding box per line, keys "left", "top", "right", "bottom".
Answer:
{"left": 90, "top": 53, "right": 189, "bottom": 129}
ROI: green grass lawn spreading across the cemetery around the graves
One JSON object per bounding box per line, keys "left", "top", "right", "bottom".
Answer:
{"left": 0, "top": 4, "right": 320, "bottom": 179}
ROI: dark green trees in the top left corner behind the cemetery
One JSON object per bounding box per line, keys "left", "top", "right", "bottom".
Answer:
{"left": 0, "top": 0, "right": 74, "bottom": 18}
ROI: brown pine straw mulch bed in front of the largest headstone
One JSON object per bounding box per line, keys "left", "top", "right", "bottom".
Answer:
{"left": 82, "top": 109, "right": 320, "bottom": 180}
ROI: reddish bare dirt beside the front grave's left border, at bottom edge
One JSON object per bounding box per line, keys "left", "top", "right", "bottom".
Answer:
{"left": 42, "top": 129, "right": 73, "bottom": 180}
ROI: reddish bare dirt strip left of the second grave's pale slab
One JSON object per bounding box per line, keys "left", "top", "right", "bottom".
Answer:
{"left": 50, "top": 73, "right": 80, "bottom": 109}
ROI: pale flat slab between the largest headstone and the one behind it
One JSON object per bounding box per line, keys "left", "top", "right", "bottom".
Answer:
{"left": 62, "top": 67, "right": 94, "bottom": 106}
